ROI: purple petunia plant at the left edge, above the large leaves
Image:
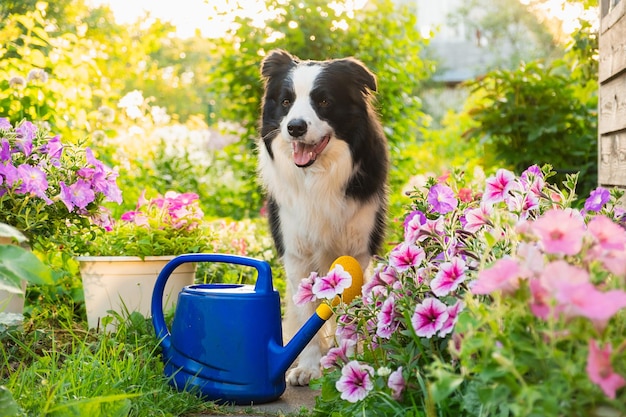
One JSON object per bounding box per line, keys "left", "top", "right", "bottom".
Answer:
{"left": 0, "top": 118, "right": 121, "bottom": 246}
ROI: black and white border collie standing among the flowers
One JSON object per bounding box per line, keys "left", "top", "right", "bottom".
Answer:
{"left": 258, "top": 50, "right": 389, "bottom": 385}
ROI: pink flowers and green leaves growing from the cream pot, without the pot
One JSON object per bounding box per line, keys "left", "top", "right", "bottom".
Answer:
{"left": 72, "top": 191, "right": 211, "bottom": 258}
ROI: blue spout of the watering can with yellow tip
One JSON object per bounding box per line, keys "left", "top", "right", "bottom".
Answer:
{"left": 269, "top": 304, "right": 333, "bottom": 381}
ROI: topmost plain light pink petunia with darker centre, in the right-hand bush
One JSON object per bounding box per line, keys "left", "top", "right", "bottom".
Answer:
{"left": 531, "top": 209, "right": 585, "bottom": 255}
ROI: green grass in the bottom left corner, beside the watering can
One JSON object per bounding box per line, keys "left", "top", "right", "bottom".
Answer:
{"left": 0, "top": 306, "right": 224, "bottom": 417}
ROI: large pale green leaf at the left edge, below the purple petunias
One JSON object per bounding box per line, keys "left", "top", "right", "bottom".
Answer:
{"left": 0, "top": 245, "right": 54, "bottom": 288}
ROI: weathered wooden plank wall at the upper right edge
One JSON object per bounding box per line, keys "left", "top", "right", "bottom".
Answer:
{"left": 598, "top": 0, "right": 626, "bottom": 188}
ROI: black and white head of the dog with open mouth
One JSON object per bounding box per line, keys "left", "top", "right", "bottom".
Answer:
{"left": 261, "top": 50, "right": 376, "bottom": 168}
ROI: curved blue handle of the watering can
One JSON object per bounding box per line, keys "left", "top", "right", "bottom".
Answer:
{"left": 151, "top": 253, "right": 274, "bottom": 350}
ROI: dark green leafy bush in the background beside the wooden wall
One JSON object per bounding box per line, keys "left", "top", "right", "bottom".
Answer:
{"left": 467, "top": 62, "right": 597, "bottom": 200}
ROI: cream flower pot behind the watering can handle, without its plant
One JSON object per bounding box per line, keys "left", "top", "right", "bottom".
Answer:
{"left": 76, "top": 256, "right": 196, "bottom": 331}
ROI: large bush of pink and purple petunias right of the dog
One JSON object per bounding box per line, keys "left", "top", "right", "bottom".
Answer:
{"left": 306, "top": 166, "right": 626, "bottom": 416}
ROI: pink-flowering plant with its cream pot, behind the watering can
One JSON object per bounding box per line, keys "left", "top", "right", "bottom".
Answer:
{"left": 70, "top": 191, "right": 211, "bottom": 329}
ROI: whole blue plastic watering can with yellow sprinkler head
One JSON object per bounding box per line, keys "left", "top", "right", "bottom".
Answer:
{"left": 152, "top": 254, "right": 363, "bottom": 404}
